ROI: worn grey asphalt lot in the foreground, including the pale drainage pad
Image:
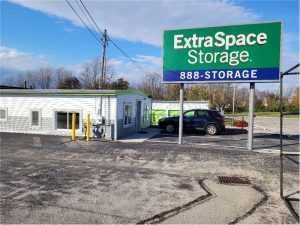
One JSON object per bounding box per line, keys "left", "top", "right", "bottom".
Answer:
{"left": 0, "top": 133, "right": 299, "bottom": 223}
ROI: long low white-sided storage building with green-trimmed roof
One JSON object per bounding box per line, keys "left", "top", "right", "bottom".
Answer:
{"left": 0, "top": 89, "right": 151, "bottom": 140}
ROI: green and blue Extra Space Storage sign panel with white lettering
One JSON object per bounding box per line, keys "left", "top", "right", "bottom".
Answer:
{"left": 163, "top": 22, "right": 281, "bottom": 83}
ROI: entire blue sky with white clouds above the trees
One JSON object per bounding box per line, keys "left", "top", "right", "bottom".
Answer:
{"left": 0, "top": 0, "right": 299, "bottom": 89}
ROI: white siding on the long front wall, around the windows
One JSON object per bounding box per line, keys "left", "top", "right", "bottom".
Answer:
{"left": 0, "top": 96, "right": 116, "bottom": 135}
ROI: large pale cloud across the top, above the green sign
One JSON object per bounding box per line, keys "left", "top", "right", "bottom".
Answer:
{"left": 11, "top": 0, "right": 258, "bottom": 46}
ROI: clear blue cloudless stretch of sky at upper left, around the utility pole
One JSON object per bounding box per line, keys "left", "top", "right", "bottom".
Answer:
{"left": 2, "top": 1, "right": 160, "bottom": 65}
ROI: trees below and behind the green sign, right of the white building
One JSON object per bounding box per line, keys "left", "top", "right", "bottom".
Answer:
{"left": 138, "top": 73, "right": 300, "bottom": 112}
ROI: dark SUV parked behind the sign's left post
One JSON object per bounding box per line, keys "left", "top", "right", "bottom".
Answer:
{"left": 158, "top": 109, "right": 225, "bottom": 135}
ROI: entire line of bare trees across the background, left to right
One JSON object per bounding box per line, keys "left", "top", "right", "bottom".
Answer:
{"left": 6, "top": 59, "right": 300, "bottom": 112}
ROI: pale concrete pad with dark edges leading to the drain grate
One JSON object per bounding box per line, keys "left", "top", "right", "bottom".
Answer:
{"left": 163, "top": 180, "right": 266, "bottom": 224}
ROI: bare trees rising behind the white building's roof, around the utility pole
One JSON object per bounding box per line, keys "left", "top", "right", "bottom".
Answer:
{"left": 5, "top": 59, "right": 129, "bottom": 89}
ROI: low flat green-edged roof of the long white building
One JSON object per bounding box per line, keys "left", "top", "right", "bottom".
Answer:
{"left": 0, "top": 89, "right": 146, "bottom": 96}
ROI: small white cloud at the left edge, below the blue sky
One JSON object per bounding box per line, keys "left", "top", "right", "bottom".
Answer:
{"left": 0, "top": 46, "right": 49, "bottom": 71}
